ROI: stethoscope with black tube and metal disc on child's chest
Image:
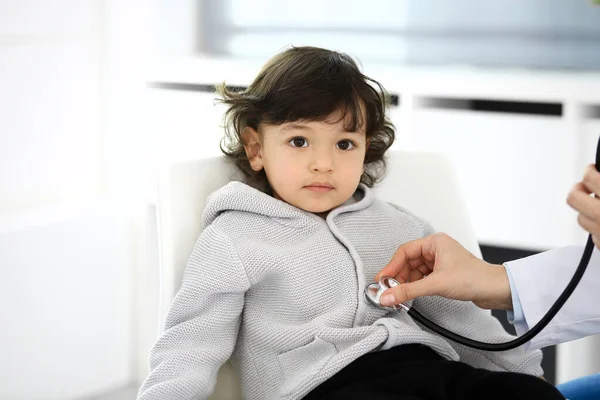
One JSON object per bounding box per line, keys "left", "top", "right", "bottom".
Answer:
{"left": 365, "top": 138, "right": 600, "bottom": 351}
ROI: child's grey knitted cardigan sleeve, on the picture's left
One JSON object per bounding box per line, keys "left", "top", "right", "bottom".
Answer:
{"left": 138, "top": 226, "right": 250, "bottom": 400}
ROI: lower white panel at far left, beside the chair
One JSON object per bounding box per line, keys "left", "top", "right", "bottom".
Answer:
{"left": 0, "top": 210, "right": 133, "bottom": 400}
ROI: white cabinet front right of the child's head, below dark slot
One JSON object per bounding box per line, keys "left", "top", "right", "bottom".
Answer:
{"left": 404, "top": 107, "right": 571, "bottom": 249}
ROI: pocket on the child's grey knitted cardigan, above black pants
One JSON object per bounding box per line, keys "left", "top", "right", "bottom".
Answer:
{"left": 277, "top": 336, "right": 337, "bottom": 396}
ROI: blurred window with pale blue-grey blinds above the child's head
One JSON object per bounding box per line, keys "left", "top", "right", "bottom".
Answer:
{"left": 198, "top": 0, "right": 600, "bottom": 69}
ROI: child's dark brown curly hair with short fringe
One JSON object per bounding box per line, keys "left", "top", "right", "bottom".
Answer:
{"left": 216, "top": 47, "right": 395, "bottom": 191}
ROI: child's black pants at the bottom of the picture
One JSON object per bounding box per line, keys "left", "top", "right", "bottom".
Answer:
{"left": 304, "top": 344, "right": 564, "bottom": 400}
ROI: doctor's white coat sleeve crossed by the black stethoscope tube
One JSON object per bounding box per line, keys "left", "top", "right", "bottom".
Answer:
{"left": 504, "top": 246, "right": 600, "bottom": 349}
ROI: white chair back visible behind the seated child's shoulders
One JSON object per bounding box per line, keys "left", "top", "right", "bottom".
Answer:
{"left": 158, "top": 151, "right": 481, "bottom": 400}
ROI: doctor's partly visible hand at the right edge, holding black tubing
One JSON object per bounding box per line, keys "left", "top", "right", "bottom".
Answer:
{"left": 567, "top": 165, "right": 600, "bottom": 249}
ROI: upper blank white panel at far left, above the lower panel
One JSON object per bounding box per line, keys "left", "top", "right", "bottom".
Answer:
{"left": 0, "top": 0, "right": 104, "bottom": 212}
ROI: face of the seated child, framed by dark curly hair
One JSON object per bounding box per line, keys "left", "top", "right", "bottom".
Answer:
{"left": 246, "top": 112, "right": 368, "bottom": 214}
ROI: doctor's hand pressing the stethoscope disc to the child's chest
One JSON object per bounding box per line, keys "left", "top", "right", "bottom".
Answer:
{"left": 375, "top": 233, "right": 512, "bottom": 310}
